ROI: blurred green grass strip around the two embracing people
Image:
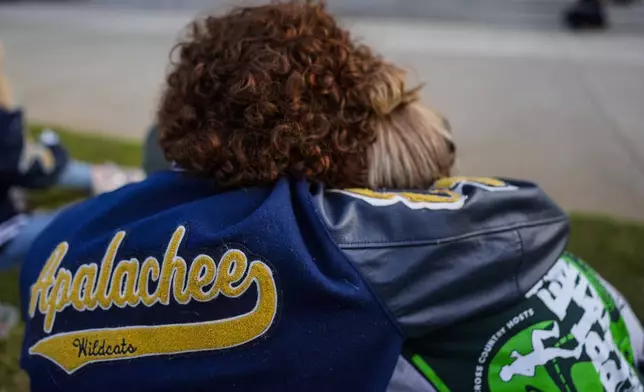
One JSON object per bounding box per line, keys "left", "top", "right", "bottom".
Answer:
{"left": 0, "top": 126, "right": 644, "bottom": 392}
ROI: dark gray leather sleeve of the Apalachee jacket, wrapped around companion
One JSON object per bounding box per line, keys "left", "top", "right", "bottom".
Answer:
{"left": 314, "top": 178, "right": 568, "bottom": 338}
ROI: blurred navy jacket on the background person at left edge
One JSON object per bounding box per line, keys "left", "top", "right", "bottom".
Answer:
{"left": 0, "top": 110, "right": 68, "bottom": 188}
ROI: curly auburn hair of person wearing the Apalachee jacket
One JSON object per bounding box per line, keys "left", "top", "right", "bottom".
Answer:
{"left": 158, "top": 1, "right": 426, "bottom": 188}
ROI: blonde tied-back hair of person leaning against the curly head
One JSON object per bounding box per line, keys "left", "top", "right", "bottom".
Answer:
{"left": 367, "top": 64, "right": 455, "bottom": 189}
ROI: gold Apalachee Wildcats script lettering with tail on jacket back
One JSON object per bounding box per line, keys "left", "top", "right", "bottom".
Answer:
{"left": 29, "top": 226, "right": 278, "bottom": 374}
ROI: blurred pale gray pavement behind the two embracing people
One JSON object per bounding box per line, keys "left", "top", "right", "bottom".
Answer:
{"left": 0, "top": 6, "right": 644, "bottom": 219}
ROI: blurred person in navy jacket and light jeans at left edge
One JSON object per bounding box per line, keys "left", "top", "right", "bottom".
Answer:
{"left": 0, "top": 43, "right": 143, "bottom": 270}
